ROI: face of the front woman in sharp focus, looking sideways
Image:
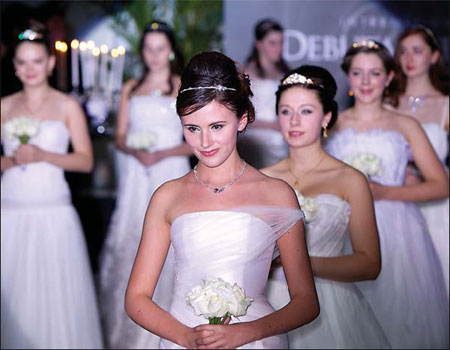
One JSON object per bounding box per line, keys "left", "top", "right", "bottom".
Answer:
{"left": 181, "top": 101, "right": 247, "bottom": 167}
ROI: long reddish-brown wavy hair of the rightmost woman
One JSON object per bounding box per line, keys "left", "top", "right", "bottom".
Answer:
{"left": 388, "top": 24, "right": 449, "bottom": 107}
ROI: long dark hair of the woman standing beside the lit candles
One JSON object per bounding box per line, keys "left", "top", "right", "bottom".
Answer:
{"left": 130, "top": 20, "right": 183, "bottom": 96}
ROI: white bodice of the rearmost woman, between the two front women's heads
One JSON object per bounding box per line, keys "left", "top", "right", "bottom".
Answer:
{"left": 251, "top": 78, "right": 279, "bottom": 122}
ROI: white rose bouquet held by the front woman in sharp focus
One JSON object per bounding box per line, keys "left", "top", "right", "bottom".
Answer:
{"left": 186, "top": 278, "right": 253, "bottom": 324}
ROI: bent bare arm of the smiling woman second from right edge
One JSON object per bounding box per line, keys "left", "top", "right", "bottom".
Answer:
{"left": 371, "top": 117, "right": 449, "bottom": 202}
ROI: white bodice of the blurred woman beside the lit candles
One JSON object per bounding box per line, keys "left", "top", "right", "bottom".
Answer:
{"left": 128, "top": 95, "right": 183, "bottom": 150}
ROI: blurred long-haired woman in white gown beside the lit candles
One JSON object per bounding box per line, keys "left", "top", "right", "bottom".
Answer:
{"left": 100, "top": 21, "right": 191, "bottom": 349}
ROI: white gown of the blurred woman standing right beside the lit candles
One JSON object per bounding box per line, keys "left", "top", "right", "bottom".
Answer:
{"left": 100, "top": 96, "right": 190, "bottom": 349}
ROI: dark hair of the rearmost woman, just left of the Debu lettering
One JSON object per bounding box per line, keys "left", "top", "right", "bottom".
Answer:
{"left": 246, "top": 18, "right": 289, "bottom": 78}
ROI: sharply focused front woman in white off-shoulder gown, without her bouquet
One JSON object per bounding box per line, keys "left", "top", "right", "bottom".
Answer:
{"left": 125, "top": 52, "right": 318, "bottom": 349}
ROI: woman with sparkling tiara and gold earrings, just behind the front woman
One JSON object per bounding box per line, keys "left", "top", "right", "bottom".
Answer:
{"left": 261, "top": 66, "right": 389, "bottom": 349}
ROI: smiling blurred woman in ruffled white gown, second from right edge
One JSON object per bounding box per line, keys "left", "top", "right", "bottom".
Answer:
{"left": 326, "top": 40, "right": 449, "bottom": 349}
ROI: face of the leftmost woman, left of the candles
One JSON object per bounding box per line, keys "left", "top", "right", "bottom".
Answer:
{"left": 14, "top": 42, "right": 55, "bottom": 86}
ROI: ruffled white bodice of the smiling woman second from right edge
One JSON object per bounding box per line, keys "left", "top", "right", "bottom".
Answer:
{"left": 325, "top": 128, "right": 410, "bottom": 186}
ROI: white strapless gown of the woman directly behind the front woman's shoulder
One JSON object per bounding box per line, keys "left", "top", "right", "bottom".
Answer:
{"left": 266, "top": 194, "right": 390, "bottom": 349}
